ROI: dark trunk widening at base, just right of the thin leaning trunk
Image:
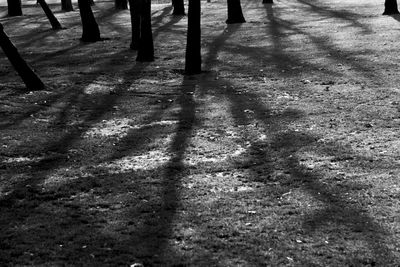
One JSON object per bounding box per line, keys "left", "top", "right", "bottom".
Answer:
{"left": 78, "top": 0, "right": 101, "bottom": 42}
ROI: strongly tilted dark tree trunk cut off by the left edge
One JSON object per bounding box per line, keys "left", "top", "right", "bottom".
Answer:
{"left": 0, "top": 23, "right": 45, "bottom": 90}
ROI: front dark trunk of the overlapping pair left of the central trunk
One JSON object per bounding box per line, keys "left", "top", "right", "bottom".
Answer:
{"left": 134, "top": 0, "right": 154, "bottom": 62}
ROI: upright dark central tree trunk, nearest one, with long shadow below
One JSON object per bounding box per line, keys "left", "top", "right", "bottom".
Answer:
{"left": 185, "top": 0, "right": 201, "bottom": 75}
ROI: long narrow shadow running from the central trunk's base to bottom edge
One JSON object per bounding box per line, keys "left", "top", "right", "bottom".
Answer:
{"left": 126, "top": 77, "right": 198, "bottom": 266}
